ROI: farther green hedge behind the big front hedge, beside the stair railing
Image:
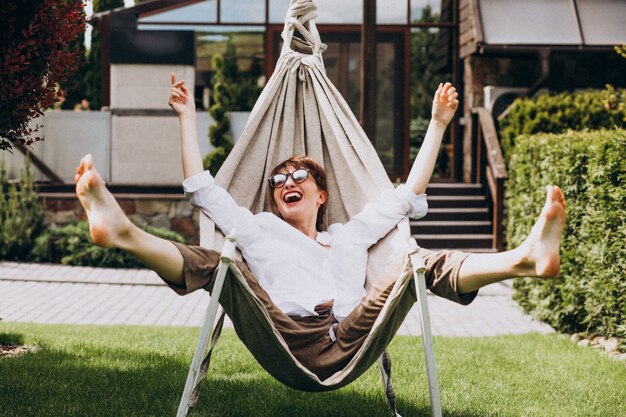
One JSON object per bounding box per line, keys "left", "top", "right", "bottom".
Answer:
{"left": 499, "top": 86, "right": 626, "bottom": 160}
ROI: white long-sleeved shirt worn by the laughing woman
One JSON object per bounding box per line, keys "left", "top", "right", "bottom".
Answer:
{"left": 183, "top": 171, "right": 428, "bottom": 320}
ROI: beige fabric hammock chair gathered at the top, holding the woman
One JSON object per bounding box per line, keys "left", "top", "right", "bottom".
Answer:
{"left": 201, "top": 0, "right": 416, "bottom": 391}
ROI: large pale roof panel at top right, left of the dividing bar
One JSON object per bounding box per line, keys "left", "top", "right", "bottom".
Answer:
{"left": 479, "top": 0, "right": 582, "bottom": 45}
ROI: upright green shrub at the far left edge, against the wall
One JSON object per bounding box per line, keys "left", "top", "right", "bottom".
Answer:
{"left": 0, "top": 160, "right": 45, "bottom": 261}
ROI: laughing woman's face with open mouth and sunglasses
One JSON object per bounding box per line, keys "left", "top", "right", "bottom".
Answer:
{"left": 273, "top": 165, "right": 326, "bottom": 226}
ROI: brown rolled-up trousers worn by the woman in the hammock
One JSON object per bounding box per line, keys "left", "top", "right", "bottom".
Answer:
{"left": 166, "top": 242, "right": 477, "bottom": 380}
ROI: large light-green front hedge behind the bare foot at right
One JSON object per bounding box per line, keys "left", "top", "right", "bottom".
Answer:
{"left": 506, "top": 129, "right": 626, "bottom": 348}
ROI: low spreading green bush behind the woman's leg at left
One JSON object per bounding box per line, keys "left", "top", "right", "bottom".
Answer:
{"left": 31, "top": 222, "right": 186, "bottom": 268}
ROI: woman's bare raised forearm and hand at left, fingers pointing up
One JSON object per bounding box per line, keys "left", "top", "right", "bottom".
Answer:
{"left": 168, "top": 73, "right": 204, "bottom": 178}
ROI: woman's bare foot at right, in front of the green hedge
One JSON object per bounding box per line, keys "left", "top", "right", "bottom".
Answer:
{"left": 518, "top": 186, "right": 567, "bottom": 278}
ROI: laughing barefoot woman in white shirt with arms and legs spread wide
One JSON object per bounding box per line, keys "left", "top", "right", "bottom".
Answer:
{"left": 76, "top": 74, "right": 565, "bottom": 379}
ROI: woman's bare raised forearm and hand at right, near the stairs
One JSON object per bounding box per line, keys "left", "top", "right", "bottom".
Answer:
{"left": 406, "top": 83, "right": 459, "bottom": 194}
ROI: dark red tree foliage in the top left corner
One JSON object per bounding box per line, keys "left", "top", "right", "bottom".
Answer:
{"left": 0, "top": 0, "right": 85, "bottom": 150}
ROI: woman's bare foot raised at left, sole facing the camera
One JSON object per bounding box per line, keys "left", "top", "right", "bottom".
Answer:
{"left": 74, "top": 154, "right": 131, "bottom": 247}
